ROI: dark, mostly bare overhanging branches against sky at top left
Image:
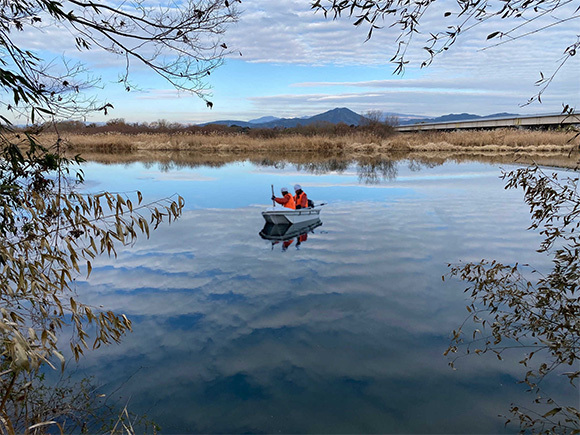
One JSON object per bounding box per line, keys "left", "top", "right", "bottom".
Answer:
{"left": 0, "top": 0, "right": 239, "bottom": 122}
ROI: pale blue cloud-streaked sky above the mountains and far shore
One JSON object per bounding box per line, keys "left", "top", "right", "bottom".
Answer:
{"left": 5, "top": 0, "right": 580, "bottom": 124}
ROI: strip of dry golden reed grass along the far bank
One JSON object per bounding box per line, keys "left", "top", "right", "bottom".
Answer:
{"left": 42, "top": 129, "right": 574, "bottom": 157}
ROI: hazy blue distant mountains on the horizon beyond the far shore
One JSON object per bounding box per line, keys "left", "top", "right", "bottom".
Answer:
{"left": 202, "top": 107, "right": 519, "bottom": 128}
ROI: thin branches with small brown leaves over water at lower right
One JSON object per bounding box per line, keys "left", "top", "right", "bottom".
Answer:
{"left": 446, "top": 166, "right": 580, "bottom": 433}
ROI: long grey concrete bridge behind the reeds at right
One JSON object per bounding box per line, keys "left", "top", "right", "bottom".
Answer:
{"left": 395, "top": 114, "right": 580, "bottom": 132}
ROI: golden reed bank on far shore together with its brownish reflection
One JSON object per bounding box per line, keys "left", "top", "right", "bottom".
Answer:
{"left": 39, "top": 129, "right": 580, "bottom": 169}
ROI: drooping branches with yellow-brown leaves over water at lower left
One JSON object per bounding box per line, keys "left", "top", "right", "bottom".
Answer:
{"left": 0, "top": 131, "right": 184, "bottom": 434}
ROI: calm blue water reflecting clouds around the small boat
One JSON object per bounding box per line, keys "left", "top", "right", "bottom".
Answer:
{"left": 62, "top": 161, "right": 577, "bottom": 433}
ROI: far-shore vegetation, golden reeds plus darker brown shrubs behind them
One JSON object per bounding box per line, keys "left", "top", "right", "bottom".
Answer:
{"left": 34, "top": 119, "right": 577, "bottom": 164}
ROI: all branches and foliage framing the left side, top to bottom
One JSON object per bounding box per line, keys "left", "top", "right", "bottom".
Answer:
{"left": 0, "top": 0, "right": 239, "bottom": 434}
